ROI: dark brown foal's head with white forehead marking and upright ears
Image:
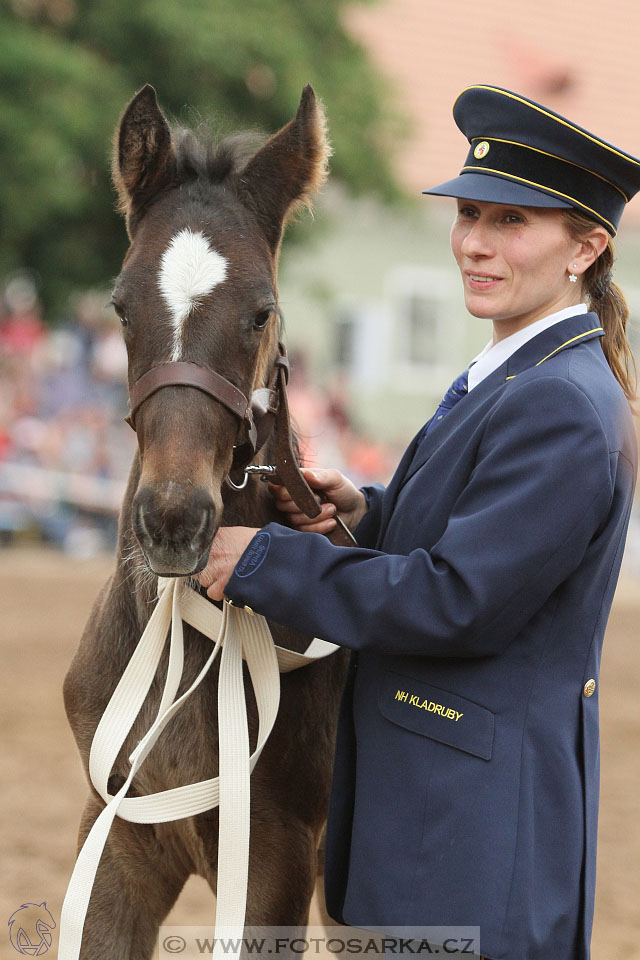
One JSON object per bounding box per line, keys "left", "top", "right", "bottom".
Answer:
{"left": 113, "top": 86, "right": 329, "bottom": 576}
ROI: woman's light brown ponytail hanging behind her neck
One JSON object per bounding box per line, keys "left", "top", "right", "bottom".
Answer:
{"left": 563, "top": 210, "right": 638, "bottom": 402}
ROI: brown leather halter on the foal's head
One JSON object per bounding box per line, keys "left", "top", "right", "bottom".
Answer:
{"left": 125, "top": 343, "right": 355, "bottom": 546}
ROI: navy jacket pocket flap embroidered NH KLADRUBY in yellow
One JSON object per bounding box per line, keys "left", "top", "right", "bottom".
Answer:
{"left": 378, "top": 672, "right": 495, "bottom": 760}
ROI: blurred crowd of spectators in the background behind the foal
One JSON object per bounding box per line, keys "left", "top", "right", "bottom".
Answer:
{"left": 0, "top": 274, "right": 396, "bottom": 557}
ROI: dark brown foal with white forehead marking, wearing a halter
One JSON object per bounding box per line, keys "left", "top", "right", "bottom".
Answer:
{"left": 64, "top": 85, "right": 347, "bottom": 960}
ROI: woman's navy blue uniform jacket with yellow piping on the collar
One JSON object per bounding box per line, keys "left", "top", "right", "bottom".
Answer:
{"left": 226, "top": 313, "right": 636, "bottom": 960}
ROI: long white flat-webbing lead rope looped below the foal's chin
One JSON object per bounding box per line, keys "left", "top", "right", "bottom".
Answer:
{"left": 58, "top": 578, "right": 337, "bottom": 960}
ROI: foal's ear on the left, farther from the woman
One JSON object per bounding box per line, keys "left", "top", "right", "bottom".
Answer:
{"left": 112, "top": 84, "right": 175, "bottom": 234}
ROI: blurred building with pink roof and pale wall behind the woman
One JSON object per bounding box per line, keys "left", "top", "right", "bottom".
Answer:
{"left": 280, "top": 0, "right": 640, "bottom": 442}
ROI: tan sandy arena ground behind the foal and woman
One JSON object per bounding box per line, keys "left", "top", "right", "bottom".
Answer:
{"left": 0, "top": 546, "right": 640, "bottom": 960}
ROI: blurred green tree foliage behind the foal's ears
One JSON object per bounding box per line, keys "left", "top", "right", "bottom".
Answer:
{"left": 0, "top": 0, "right": 400, "bottom": 309}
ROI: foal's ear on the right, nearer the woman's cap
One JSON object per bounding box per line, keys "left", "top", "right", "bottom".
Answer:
{"left": 238, "top": 85, "right": 331, "bottom": 253}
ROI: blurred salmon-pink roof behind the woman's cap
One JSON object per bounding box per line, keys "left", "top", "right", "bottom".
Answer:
{"left": 348, "top": 0, "right": 640, "bottom": 224}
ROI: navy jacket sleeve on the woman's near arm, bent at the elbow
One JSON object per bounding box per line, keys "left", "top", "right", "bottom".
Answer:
{"left": 225, "top": 377, "right": 613, "bottom": 657}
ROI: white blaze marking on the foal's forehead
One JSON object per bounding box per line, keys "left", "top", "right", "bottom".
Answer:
{"left": 158, "top": 227, "right": 227, "bottom": 360}
